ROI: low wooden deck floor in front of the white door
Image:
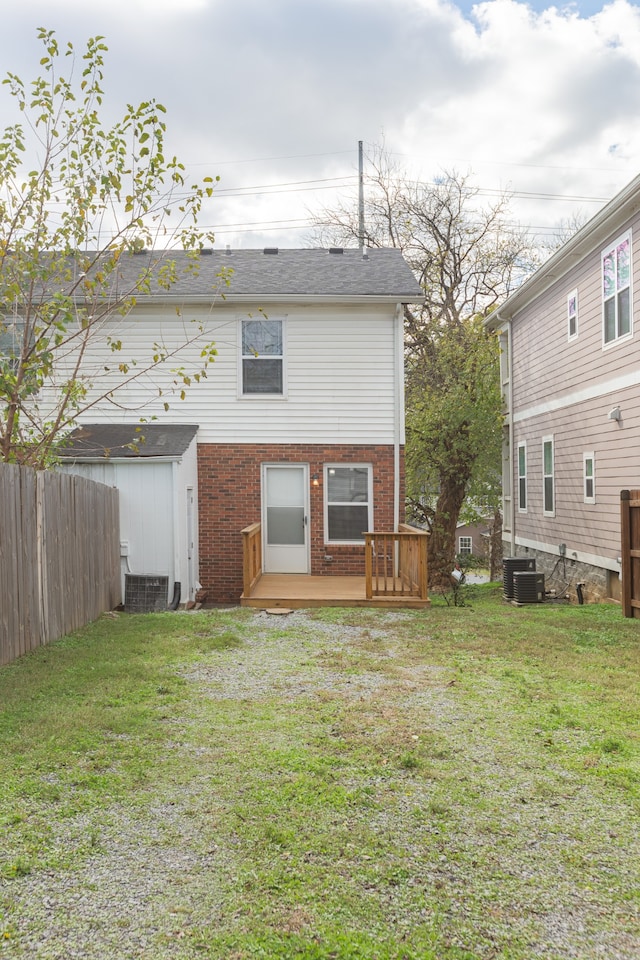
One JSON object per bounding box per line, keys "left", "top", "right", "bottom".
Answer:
{"left": 240, "top": 573, "right": 430, "bottom": 610}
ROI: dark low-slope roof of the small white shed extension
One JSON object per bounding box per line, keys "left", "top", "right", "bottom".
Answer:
{"left": 58, "top": 423, "right": 198, "bottom": 460}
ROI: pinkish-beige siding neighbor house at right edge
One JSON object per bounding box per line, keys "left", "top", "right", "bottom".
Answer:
{"left": 488, "top": 176, "right": 640, "bottom": 600}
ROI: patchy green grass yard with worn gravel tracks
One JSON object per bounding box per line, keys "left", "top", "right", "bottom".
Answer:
{"left": 0, "top": 587, "right": 640, "bottom": 960}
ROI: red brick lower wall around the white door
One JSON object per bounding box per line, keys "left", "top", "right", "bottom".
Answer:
{"left": 198, "top": 443, "right": 404, "bottom": 603}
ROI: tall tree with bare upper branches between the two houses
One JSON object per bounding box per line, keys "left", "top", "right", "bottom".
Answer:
{"left": 317, "top": 150, "right": 531, "bottom": 582}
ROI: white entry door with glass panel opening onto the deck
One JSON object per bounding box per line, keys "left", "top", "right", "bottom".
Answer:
{"left": 262, "top": 463, "right": 309, "bottom": 573}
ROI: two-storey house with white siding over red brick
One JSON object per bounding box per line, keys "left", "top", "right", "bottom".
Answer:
{"left": 56, "top": 249, "right": 422, "bottom": 602}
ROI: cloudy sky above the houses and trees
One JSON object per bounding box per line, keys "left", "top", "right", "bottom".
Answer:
{"left": 0, "top": 0, "right": 640, "bottom": 248}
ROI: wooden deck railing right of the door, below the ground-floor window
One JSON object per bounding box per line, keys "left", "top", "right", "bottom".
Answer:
{"left": 364, "top": 524, "right": 429, "bottom": 600}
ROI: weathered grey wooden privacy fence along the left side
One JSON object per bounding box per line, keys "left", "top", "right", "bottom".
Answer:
{"left": 0, "top": 464, "right": 121, "bottom": 664}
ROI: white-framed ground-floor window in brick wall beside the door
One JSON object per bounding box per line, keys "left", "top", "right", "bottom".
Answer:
{"left": 324, "top": 464, "right": 373, "bottom": 543}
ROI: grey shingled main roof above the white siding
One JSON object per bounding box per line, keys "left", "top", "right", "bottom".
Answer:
{"left": 71, "top": 247, "right": 424, "bottom": 303}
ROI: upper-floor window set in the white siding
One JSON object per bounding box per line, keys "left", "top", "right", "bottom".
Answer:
{"left": 241, "top": 319, "right": 284, "bottom": 396}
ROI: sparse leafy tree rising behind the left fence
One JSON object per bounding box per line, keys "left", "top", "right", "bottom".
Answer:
{"left": 0, "top": 29, "right": 222, "bottom": 467}
